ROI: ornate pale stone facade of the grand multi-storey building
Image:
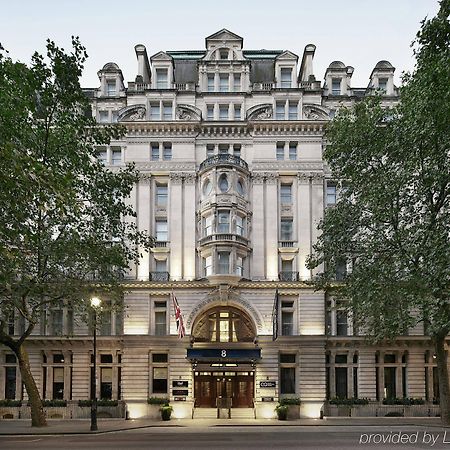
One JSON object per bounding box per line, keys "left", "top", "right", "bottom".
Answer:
{"left": 0, "top": 29, "right": 438, "bottom": 417}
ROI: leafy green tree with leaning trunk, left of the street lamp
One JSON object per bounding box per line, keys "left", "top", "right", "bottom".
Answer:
{"left": 0, "top": 38, "right": 151, "bottom": 426}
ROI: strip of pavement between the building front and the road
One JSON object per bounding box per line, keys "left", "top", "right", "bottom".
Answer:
{"left": 0, "top": 417, "right": 441, "bottom": 436}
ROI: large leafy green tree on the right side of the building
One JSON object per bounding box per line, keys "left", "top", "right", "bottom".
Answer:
{"left": 309, "top": 0, "right": 450, "bottom": 424}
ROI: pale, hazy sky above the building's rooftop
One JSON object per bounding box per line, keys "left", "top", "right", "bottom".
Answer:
{"left": 0, "top": 0, "right": 439, "bottom": 87}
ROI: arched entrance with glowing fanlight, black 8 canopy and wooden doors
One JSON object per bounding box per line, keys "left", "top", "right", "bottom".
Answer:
{"left": 191, "top": 306, "right": 259, "bottom": 408}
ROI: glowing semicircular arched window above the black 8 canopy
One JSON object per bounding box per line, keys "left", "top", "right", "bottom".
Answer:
{"left": 192, "top": 306, "right": 256, "bottom": 342}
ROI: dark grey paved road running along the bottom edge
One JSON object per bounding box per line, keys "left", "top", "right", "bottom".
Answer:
{"left": 0, "top": 426, "right": 450, "bottom": 450}
